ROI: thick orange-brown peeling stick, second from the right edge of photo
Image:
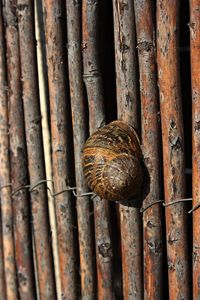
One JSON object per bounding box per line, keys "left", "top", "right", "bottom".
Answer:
{"left": 157, "top": 0, "right": 190, "bottom": 300}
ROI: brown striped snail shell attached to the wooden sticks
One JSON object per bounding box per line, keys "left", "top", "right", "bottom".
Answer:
{"left": 83, "top": 121, "right": 143, "bottom": 201}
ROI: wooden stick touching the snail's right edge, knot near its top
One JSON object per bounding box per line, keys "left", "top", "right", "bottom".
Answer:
{"left": 134, "top": 0, "right": 163, "bottom": 300}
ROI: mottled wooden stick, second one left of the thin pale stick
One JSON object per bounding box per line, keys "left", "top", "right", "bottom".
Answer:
{"left": 4, "top": 1, "right": 35, "bottom": 300}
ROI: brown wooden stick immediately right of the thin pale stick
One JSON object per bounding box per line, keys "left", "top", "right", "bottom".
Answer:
{"left": 44, "top": 0, "right": 78, "bottom": 300}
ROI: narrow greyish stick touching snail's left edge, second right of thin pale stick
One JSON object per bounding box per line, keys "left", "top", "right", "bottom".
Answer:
{"left": 66, "top": 1, "right": 95, "bottom": 300}
